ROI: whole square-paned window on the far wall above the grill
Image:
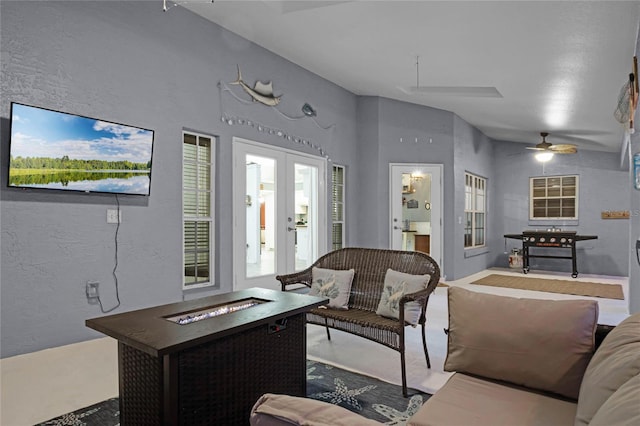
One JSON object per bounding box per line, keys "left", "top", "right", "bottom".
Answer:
{"left": 529, "top": 175, "right": 578, "bottom": 220}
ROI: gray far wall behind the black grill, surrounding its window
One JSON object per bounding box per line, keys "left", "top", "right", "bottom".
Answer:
{"left": 492, "top": 142, "right": 629, "bottom": 276}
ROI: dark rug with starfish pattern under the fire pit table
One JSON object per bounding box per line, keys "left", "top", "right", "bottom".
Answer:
{"left": 37, "top": 360, "right": 430, "bottom": 426}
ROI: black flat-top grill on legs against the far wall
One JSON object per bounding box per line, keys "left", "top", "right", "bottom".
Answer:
{"left": 504, "top": 229, "right": 598, "bottom": 278}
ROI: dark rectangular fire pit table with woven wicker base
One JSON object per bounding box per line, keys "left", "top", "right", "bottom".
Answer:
{"left": 86, "top": 288, "right": 328, "bottom": 426}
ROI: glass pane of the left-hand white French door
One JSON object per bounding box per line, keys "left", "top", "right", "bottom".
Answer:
{"left": 245, "top": 155, "right": 277, "bottom": 278}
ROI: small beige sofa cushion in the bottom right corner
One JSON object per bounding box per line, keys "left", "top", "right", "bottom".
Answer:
{"left": 589, "top": 375, "right": 640, "bottom": 426}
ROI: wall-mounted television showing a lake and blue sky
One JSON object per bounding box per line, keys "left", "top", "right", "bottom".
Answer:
{"left": 8, "top": 102, "right": 154, "bottom": 195}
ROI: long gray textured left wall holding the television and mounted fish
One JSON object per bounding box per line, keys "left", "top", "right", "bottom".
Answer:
{"left": 0, "top": 1, "right": 357, "bottom": 357}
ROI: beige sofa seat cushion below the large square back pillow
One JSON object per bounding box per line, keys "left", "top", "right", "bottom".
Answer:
{"left": 407, "top": 373, "right": 576, "bottom": 426}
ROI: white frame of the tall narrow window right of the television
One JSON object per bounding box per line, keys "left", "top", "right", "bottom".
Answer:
{"left": 181, "top": 130, "right": 217, "bottom": 290}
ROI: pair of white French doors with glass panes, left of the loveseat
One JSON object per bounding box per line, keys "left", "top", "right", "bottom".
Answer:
{"left": 233, "top": 138, "right": 327, "bottom": 290}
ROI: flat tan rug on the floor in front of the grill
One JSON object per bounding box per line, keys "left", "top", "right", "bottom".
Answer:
{"left": 471, "top": 274, "right": 624, "bottom": 300}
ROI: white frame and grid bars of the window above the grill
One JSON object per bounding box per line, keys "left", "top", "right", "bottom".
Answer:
{"left": 529, "top": 175, "right": 580, "bottom": 221}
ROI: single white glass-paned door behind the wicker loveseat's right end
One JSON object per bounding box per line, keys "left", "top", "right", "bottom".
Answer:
{"left": 389, "top": 163, "right": 443, "bottom": 269}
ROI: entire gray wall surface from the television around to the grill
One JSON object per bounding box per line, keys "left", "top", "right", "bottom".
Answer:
{"left": 0, "top": 1, "right": 637, "bottom": 357}
